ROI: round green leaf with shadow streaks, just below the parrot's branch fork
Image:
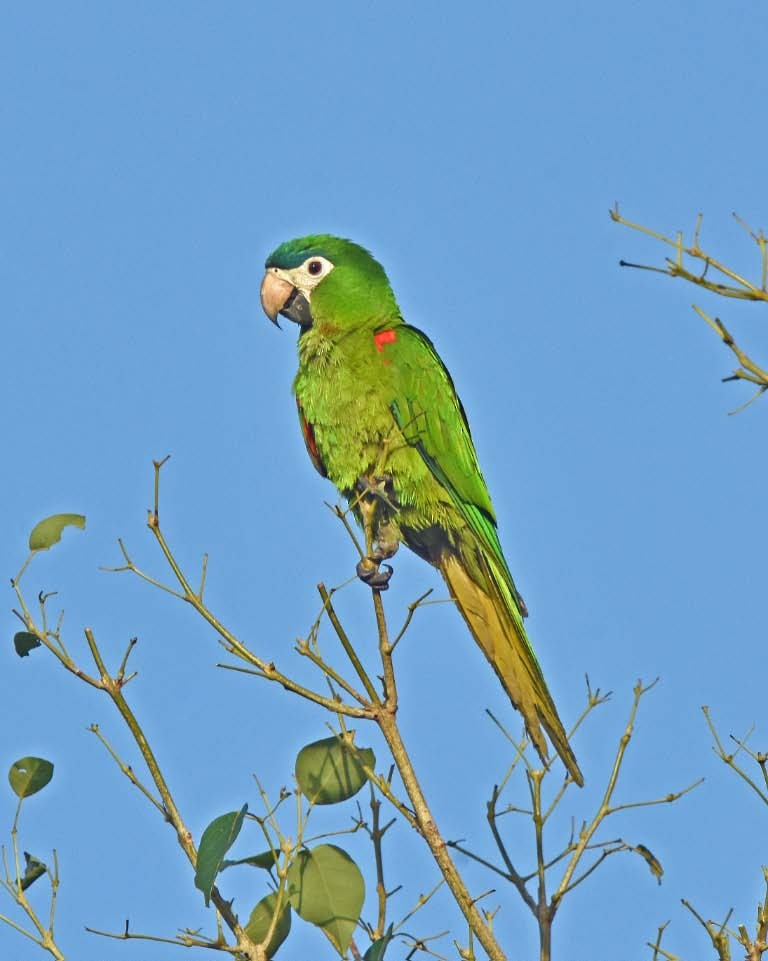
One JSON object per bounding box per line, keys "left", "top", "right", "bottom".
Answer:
{"left": 296, "top": 737, "right": 376, "bottom": 804}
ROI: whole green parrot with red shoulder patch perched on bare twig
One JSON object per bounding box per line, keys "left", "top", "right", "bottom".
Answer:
{"left": 261, "top": 234, "right": 584, "bottom": 785}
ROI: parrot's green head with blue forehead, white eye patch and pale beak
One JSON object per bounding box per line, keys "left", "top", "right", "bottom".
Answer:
{"left": 261, "top": 234, "right": 398, "bottom": 330}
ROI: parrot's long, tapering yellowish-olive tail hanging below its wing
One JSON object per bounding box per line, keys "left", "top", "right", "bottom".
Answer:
{"left": 438, "top": 551, "right": 584, "bottom": 787}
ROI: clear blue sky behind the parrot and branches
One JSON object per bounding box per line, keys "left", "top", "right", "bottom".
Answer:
{"left": 0, "top": 0, "right": 768, "bottom": 961}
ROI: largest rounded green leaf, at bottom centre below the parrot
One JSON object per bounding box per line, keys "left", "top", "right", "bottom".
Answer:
{"left": 288, "top": 844, "right": 365, "bottom": 954}
